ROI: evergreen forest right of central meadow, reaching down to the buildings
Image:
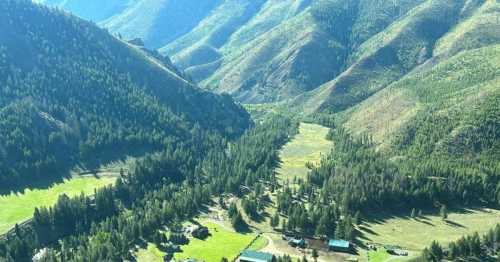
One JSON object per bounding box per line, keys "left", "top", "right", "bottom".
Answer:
{"left": 264, "top": 123, "right": 500, "bottom": 244}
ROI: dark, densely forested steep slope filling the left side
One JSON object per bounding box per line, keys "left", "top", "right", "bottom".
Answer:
{"left": 0, "top": 0, "right": 249, "bottom": 187}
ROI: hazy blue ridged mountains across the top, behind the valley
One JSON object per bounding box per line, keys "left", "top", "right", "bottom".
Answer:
{"left": 38, "top": 0, "right": 500, "bottom": 109}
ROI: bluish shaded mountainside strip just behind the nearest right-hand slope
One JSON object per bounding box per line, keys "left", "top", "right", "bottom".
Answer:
{"left": 308, "top": 0, "right": 464, "bottom": 112}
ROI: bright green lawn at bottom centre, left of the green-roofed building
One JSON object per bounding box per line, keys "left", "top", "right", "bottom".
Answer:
{"left": 175, "top": 223, "right": 256, "bottom": 262}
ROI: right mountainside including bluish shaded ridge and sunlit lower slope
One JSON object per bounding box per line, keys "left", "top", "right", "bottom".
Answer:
{"left": 302, "top": 1, "right": 500, "bottom": 165}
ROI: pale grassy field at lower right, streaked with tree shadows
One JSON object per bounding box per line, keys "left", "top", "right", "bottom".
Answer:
{"left": 361, "top": 209, "right": 500, "bottom": 251}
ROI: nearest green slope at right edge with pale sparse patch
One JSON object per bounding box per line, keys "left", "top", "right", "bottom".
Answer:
{"left": 345, "top": 45, "right": 500, "bottom": 163}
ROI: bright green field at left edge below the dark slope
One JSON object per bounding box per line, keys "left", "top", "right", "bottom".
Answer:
{"left": 0, "top": 176, "right": 116, "bottom": 234}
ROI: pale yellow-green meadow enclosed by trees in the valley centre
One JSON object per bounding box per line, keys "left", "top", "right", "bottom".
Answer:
{"left": 278, "top": 123, "right": 333, "bottom": 182}
